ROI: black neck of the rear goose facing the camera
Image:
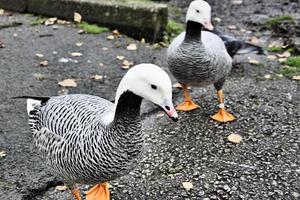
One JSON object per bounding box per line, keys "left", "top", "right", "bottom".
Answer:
{"left": 184, "top": 21, "right": 203, "bottom": 41}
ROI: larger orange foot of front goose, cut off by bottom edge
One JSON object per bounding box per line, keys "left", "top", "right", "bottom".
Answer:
{"left": 86, "top": 183, "right": 110, "bottom": 200}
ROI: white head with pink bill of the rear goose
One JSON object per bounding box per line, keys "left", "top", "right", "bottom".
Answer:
{"left": 186, "top": 0, "right": 214, "bottom": 30}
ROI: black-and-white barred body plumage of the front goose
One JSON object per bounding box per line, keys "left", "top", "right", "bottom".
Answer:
{"left": 29, "top": 95, "right": 143, "bottom": 184}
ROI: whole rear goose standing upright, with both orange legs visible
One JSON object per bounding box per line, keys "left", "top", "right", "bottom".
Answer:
{"left": 167, "top": 0, "right": 235, "bottom": 122}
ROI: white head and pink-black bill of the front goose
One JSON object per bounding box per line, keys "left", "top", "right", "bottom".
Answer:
{"left": 115, "top": 64, "right": 178, "bottom": 121}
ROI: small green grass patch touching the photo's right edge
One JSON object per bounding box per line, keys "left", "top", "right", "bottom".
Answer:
{"left": 281, "top": 56, "right": 300, "bottom": 77}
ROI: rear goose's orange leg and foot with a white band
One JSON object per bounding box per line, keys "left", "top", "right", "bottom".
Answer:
{"left": 211, "top": 90, "right": 235, "bottom": 122}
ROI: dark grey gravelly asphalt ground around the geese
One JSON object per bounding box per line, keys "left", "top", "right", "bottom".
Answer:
{"left": 0, "top": 0, "right": 300, "bottom": 200}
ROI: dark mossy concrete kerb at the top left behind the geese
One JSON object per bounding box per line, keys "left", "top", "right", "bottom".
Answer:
{"left": 0, "top": 0, "right": 168, "bottom": 42}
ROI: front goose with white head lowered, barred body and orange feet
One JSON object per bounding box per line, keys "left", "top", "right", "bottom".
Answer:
{"left": 18, "top": 64, "right": 178, "bottom": 200}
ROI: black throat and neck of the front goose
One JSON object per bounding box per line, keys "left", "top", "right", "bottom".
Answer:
{"left": 113, "top": 91, "right": 143, "bottom": 126}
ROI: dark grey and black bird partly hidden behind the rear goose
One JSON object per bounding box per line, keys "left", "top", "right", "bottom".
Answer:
{"left": 212, "top": 29, "right": 264, "bottom": 57}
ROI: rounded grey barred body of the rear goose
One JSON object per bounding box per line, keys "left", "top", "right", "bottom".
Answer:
{"left": 167, "top": 22, "right": 232, "bottom": 86}
